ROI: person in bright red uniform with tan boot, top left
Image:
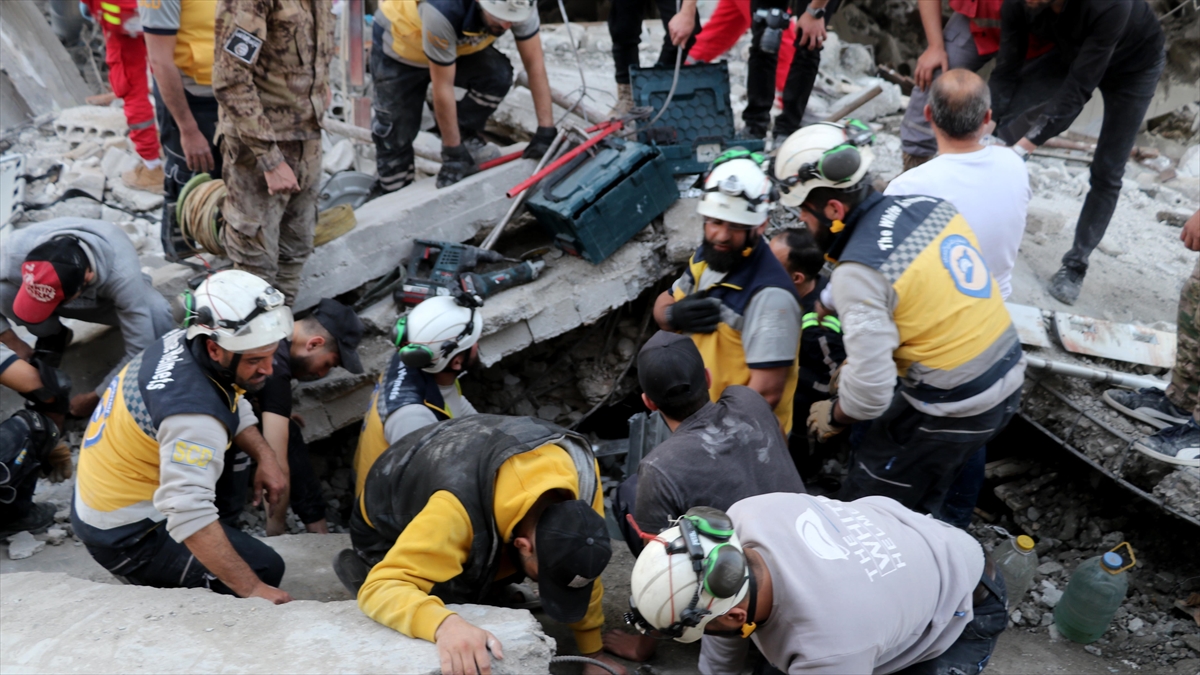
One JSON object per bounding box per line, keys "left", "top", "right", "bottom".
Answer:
{"left": 84, "top": 0, "right": 163, "bottom": 195}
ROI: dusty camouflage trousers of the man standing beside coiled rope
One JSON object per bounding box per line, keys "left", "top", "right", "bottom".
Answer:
{"left": 221, "top": 135, "right": 322, "bottom": 306}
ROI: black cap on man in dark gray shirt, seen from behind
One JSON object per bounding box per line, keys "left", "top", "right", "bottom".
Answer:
{"left": 637, "top": 330, "right": 708, "bottom": 407}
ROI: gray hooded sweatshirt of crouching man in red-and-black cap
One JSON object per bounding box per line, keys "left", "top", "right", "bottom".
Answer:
{"left": 0, "top": 217, "right": 174, "bottom": 392}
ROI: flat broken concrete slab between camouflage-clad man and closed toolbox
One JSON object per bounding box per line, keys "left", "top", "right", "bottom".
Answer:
{"left": 295, "top": 160, "right": 536, "bottom": 310}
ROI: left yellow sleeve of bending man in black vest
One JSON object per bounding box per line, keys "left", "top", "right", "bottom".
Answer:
{"left": 359, "top": 490, "right": 472, "bottom": 644}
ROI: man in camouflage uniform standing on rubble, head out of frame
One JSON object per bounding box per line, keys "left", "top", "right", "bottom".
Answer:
{"left": 212, "top": 0, "right": 336, "bottom": 305}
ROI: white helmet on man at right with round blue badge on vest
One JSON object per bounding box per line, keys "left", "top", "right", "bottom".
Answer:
{"left": 775, "top": 120, "right": 875, "bottom": 207}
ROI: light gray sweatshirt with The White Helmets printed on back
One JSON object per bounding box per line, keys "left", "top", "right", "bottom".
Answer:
{"left": 700, "top": 492, "right": 984, "bottom": 675}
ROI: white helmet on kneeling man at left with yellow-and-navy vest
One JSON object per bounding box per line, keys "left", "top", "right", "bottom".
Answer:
{"left": 180, "top": 269, "right": 292, "bottom": 353}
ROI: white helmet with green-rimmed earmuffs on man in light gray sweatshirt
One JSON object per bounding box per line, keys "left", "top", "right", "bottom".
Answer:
{"left": 625, "top": 507, "right": 750, "bottom": 643}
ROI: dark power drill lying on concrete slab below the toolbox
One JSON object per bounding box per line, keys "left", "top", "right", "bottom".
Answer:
{"left": 392, "top": 239, "right": 545, "bottom": 306}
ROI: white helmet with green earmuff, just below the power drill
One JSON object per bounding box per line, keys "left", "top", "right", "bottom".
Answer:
{"left": 395, "top": 295, "right": 484, "bottom": 372}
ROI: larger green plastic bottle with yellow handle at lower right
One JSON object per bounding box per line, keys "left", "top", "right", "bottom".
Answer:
{"left": 1054, "top": 551, "right": 1129, "bottom": 645}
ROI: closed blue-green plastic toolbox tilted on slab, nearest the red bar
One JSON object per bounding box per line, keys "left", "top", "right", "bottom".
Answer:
{"left": 526, "top": 139, "right": 679, "bottom": 263}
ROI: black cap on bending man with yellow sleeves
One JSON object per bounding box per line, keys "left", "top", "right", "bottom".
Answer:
{"left": 536, "top": 500, "right": 612, "bottom": 623}
